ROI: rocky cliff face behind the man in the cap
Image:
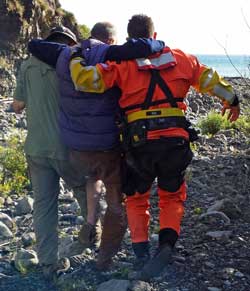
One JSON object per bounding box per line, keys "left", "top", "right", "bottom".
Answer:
{"left": 0, "top": 0, "right": 79, "bottom": 97}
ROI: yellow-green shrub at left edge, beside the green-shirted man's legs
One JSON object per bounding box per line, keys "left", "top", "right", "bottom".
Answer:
{"left": 0, "top": 133, "right": 29, "bottom": 195}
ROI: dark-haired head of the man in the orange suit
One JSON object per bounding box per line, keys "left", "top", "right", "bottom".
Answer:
{"left": 127, "top": 14, "right": 154, "bottom": 38}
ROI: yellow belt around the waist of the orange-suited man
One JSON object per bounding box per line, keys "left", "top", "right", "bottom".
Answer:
{"left": 127, "top": 108, "right": 184, "bottom": 123}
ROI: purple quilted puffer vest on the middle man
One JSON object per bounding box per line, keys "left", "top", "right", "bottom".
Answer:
{"left": 56, "top": 39, "right": 120, "bottom": 151}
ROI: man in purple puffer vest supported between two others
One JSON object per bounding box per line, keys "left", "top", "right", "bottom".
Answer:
{"left": 29, "top": 22, "right": 164, "bottom": 270}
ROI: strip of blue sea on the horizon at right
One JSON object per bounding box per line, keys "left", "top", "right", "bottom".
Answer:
{"left": 196, "top": 54, "right": 250, "bottom": 78}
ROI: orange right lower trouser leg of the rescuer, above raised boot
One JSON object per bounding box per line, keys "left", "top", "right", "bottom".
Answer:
{"left": 158, "top": 182, "right": 187, "bottom": 235}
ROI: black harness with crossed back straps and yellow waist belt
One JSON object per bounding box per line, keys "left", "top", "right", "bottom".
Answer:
{"left": 120, "top": 69, "right": 197, "bottom": 150}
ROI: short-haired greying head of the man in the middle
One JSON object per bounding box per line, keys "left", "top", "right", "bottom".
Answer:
{"left": 90, "top": 22, "right": 117, "bottom": 45}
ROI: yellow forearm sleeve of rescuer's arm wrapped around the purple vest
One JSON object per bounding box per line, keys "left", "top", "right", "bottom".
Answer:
{"left": 70, "top": 58, "right": 105, "bottom": 93}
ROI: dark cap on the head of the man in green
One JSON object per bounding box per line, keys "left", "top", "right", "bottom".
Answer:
{"left": 46, "top": 26, "right": 77, "bottom": 46}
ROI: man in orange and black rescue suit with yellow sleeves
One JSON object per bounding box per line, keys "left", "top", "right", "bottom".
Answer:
{"left": 70, "top": 15, "right": 240, "bottom": 279}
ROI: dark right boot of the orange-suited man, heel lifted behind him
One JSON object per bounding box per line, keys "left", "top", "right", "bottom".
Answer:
{"left": 137, "top": 244, "right": 173, "bottom": 281}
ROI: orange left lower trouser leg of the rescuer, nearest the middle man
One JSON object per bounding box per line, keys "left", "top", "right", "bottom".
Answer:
{"left": 126, "top": 191, "right": 150, "bottom": 243}
